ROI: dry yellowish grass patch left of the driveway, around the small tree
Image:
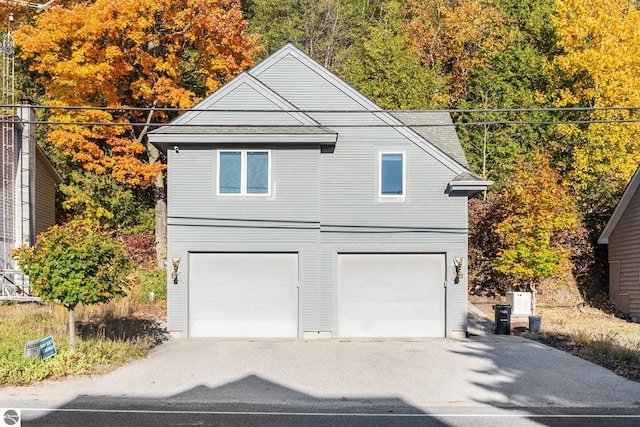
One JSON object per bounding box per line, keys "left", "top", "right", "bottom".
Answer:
{"left": 0, "top": 276, "right": 166, "bottom": 387}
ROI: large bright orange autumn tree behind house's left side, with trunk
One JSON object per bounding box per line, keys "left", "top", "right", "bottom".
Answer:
{"left": 14, "top": 0, "right": 259, "bottom": 262}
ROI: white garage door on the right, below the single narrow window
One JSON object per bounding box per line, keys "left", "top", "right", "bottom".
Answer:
{"left": 337, "top": 254, "right": 445, "bottom": 337}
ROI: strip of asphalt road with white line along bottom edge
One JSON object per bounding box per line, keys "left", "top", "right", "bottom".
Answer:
{"left": 8, "top": 407, "right": 640, "bottom": 427}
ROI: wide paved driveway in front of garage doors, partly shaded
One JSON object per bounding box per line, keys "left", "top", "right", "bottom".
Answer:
{"left": 0, "top": 310, "right": 640, "bottom": 421}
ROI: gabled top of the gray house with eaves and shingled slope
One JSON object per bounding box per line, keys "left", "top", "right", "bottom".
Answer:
{"left": 149, "top": 43, "right": 492, "bottom": 189}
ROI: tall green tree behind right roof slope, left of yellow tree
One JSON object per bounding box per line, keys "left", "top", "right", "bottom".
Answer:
{"left": 458, "top": 0, "right": 567, "bottom": 188}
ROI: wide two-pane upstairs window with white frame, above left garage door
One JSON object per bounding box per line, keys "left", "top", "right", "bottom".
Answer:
{"left": 218, "top": 150, "right": 271, "bottom": 196}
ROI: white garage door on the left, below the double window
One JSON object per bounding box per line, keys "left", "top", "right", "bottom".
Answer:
{"left": 189, "top": 253, "right": 298, "bottom": 338}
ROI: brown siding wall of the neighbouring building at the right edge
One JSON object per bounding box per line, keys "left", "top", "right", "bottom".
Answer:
{"left": 609, "top": 187, "right": 640, "bottom": 316}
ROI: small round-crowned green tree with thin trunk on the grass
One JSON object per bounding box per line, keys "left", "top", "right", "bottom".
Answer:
{"left": 13, "top": 220, "right": 132, "bottom": 354}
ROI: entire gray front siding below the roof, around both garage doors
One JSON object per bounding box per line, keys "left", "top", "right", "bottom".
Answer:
{"left": 162, "top": 136, "right": 467, "bottom": 334}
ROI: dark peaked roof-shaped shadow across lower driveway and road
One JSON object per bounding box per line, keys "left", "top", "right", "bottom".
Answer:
{"left": 22, "top": 375, "right": 440, "bottom": 427}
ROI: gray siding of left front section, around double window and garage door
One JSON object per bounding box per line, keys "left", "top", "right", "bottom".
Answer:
{"left": 168, "top": 146, "right": 319, "bottom": 331}
